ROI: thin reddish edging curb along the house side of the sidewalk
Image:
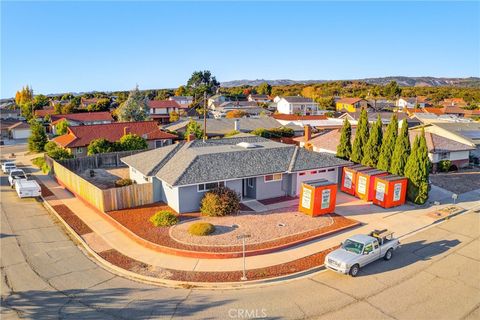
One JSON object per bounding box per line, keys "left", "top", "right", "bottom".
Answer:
{"left": 55, "top": 178, "right": 362, "bottom": 259}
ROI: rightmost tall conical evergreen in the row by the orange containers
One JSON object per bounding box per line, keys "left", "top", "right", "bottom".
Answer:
{"left": 405, "top": 129, "right": 430, "bottom": 204}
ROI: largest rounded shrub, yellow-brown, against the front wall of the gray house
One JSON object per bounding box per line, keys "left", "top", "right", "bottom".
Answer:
{"left": 200, "top": 187, "right": 240, "bottom": 217}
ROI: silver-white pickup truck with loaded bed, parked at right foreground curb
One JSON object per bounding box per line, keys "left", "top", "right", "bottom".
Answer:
{"left": 325, "top": 230, "right": 400, "bottom": 277}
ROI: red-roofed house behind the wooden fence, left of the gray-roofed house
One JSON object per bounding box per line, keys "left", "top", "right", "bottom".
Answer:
{"left": 52, "top": 121, "right": 176, "bottom": 157}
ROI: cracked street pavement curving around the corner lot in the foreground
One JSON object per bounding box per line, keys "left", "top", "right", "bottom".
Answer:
{"left": 0, "top": 168, "right": 480, "bottom": 319}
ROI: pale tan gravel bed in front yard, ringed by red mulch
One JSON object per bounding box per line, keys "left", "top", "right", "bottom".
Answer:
{"left": 170, "top": 209, "right": 334, "bottom": 247}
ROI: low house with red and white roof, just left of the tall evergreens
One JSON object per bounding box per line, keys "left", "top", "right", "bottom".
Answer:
{"left": 272, "top": 114, "right": 357, "bottom": 130}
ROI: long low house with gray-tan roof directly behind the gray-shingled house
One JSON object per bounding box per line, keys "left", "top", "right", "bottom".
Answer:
{"left": 163, "top": 117, "right": 303, "bottom": 138}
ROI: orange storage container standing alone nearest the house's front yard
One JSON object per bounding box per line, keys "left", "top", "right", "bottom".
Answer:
{"left": 298, "top": 179, "right": 337, "bottom": 217}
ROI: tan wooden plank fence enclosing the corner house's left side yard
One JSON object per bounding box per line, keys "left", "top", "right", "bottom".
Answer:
{"left": 52, "top": 158, "right": 154, "bottom": 212}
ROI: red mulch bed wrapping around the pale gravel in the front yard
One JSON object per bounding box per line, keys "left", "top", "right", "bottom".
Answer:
{"left": 108, "top": 203, "right": 358, "bottom": 252}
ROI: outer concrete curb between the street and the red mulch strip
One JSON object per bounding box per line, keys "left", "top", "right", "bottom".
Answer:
{"left": 41, "top": 196, "right": 332, "bottom": 290}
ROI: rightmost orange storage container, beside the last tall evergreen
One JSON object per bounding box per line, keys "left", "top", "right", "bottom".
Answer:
{"left": 373, "top": 175, "right": 407, "bottom": 208}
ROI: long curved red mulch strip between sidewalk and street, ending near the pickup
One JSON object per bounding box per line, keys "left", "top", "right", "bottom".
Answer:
{"left": 99, "top": 248, "right": 336, "bottom": 282}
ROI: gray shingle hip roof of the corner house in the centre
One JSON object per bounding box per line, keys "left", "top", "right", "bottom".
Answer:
{"left": 122, "top": 136, "right": 349, "bottom": 186}
